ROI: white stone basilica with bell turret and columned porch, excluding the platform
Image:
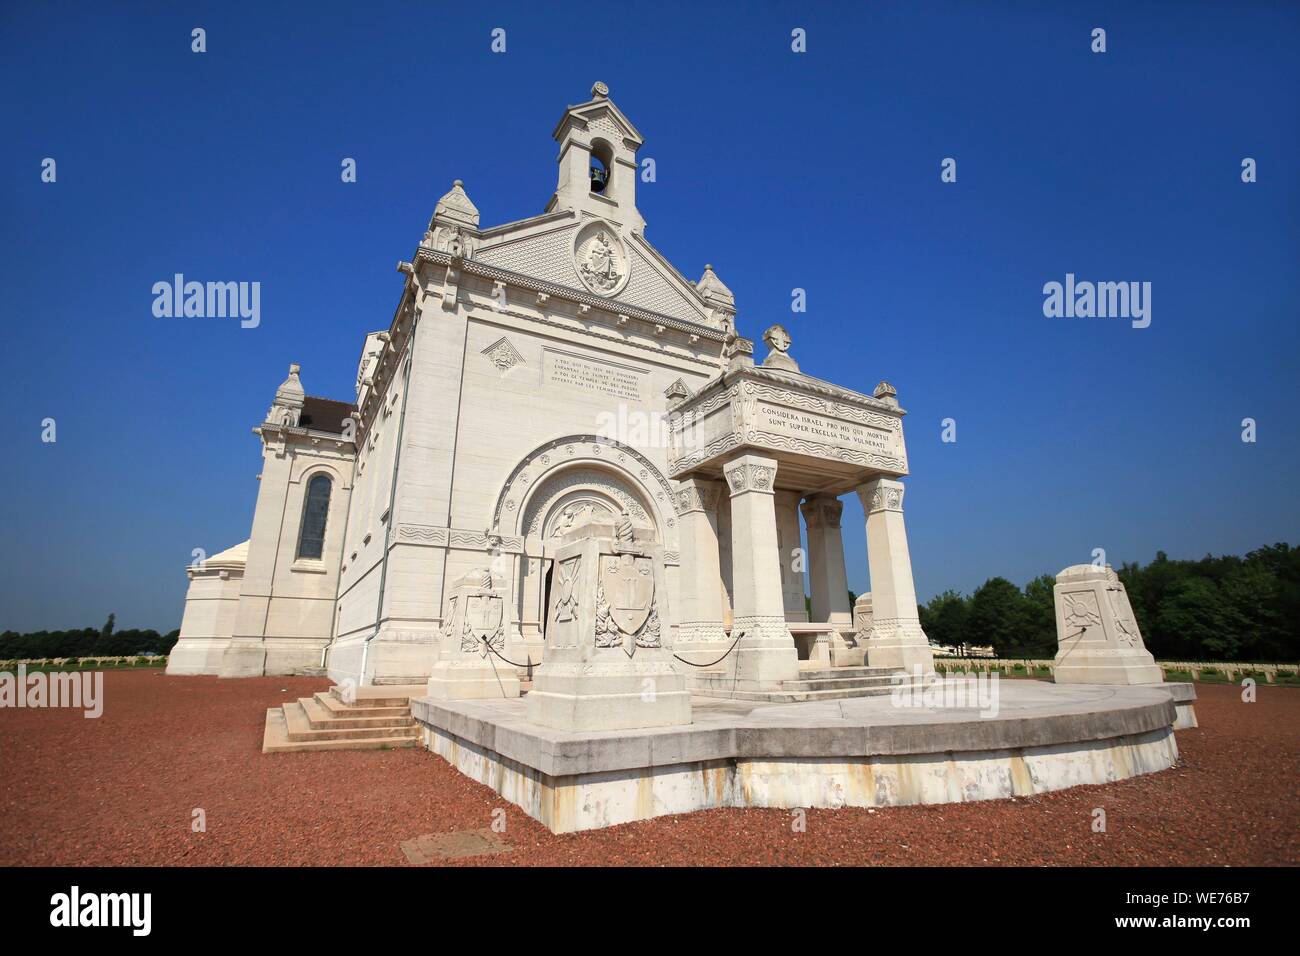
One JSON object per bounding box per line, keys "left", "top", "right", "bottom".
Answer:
{"left": 168, "top": 83, "right": 932, "bottom": 691}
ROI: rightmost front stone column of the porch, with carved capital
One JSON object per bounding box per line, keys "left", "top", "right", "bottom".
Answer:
{"left": 858, "top": 477, "right": 935, "bottom": 675}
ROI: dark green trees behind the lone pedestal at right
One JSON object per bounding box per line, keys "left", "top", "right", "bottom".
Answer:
{"left": 919, "top": 542, "right": 1300, "bottom": 663}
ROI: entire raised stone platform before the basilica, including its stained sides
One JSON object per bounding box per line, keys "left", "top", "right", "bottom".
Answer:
{"left": 411, "top": 680, "right": 1178, "bottom": 832}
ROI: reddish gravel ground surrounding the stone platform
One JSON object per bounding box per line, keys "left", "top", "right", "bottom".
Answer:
{"left": 0, "top": 671, "right": 1300, "bottom": 866}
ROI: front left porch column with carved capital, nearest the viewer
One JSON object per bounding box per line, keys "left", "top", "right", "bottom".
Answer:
{"left": 723, "top": 455, "right": 800, "bottom": 689}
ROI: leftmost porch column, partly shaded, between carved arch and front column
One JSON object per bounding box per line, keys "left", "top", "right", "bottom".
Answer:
{"left": 673, "top": 477, "right": 728, "bottom": 663}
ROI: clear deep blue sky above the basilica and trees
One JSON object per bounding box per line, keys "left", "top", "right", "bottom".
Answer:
{"left": 0, "top": 0, "right": 1300, "bottom": 631}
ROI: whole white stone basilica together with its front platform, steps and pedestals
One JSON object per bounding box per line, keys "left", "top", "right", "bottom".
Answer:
{"left": 175, "top": 83, "right": 1196, "bottom": 832}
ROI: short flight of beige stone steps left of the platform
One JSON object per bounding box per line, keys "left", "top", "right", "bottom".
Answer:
{"left": 261, "top": 684, "right": 425, "bottom": 753}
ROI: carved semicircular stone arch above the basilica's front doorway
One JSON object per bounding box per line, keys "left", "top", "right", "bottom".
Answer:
{"left": 493, "top": 434, "right": 677, "bottom": 554}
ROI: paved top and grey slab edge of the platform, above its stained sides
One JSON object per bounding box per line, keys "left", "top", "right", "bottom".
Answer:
{"left": 411, "top": 680, "right": 1175, "bottom": 777}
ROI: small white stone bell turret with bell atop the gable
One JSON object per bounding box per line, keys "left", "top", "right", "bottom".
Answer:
{"left": 546, "top": 81, "right": 645, "bottom": 233}
